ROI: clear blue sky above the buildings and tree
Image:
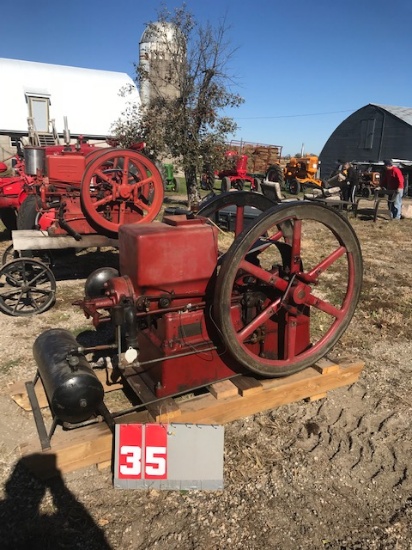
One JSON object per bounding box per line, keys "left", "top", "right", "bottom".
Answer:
{"left": 0, "top": 0, "right": 412, "bottom": 155}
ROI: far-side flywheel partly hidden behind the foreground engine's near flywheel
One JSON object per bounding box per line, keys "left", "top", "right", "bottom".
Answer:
{"left": 197, "top": 191, "right": 274, "bottom": 253}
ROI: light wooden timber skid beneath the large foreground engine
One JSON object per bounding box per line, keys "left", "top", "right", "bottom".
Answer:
{"left": 9, "top": 359, "right": 364, "bottom": 477}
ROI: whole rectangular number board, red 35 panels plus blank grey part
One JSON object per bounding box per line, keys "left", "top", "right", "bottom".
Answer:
{"left": 114, "top": 423, "right": 224, "bottom": 490}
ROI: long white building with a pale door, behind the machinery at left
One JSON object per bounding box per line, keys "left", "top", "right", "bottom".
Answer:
{"left": 0, "top": 58, "right": 140, "bottom": 160}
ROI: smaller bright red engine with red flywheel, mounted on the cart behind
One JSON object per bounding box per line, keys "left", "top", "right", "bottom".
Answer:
{"left": 18, "top": 142, "right": 163, "bottom": 240}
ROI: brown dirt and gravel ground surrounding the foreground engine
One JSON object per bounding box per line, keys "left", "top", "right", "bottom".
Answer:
{"left": 0, "top": 198, "right": 412, "bottom": 550}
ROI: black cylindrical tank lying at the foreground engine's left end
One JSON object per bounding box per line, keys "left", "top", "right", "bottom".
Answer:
{"left": 33, "top": 329, "right": 104, "bottom": 424}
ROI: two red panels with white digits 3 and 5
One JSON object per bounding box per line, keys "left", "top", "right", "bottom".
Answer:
{"left": 117, "top": 424, "right": 167, "bottom": 479}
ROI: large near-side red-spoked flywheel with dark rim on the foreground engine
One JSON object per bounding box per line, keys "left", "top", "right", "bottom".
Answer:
{"left": 213, "top": 201, "right": 362, "bottom": 377}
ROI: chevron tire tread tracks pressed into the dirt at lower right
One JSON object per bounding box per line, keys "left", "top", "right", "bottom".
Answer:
{"left": 297, "top": 383, "right": 412, "bottom": 491}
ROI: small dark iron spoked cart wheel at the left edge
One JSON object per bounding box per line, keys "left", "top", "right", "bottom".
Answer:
{"left": 0, "top": 258, "right": 56, "bottom": 317}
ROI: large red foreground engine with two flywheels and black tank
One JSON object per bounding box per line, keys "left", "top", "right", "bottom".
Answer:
{"left": 29, "top": 192, "right": 362, "bottom": 445}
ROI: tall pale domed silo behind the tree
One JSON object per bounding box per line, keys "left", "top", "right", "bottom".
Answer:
{"left": 139, "top": 22, "right": 185, "bottom": 108}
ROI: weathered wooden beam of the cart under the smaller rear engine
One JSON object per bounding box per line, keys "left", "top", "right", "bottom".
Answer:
{"left": 12, "top": 229, "right": 119, "bottom": 250}
